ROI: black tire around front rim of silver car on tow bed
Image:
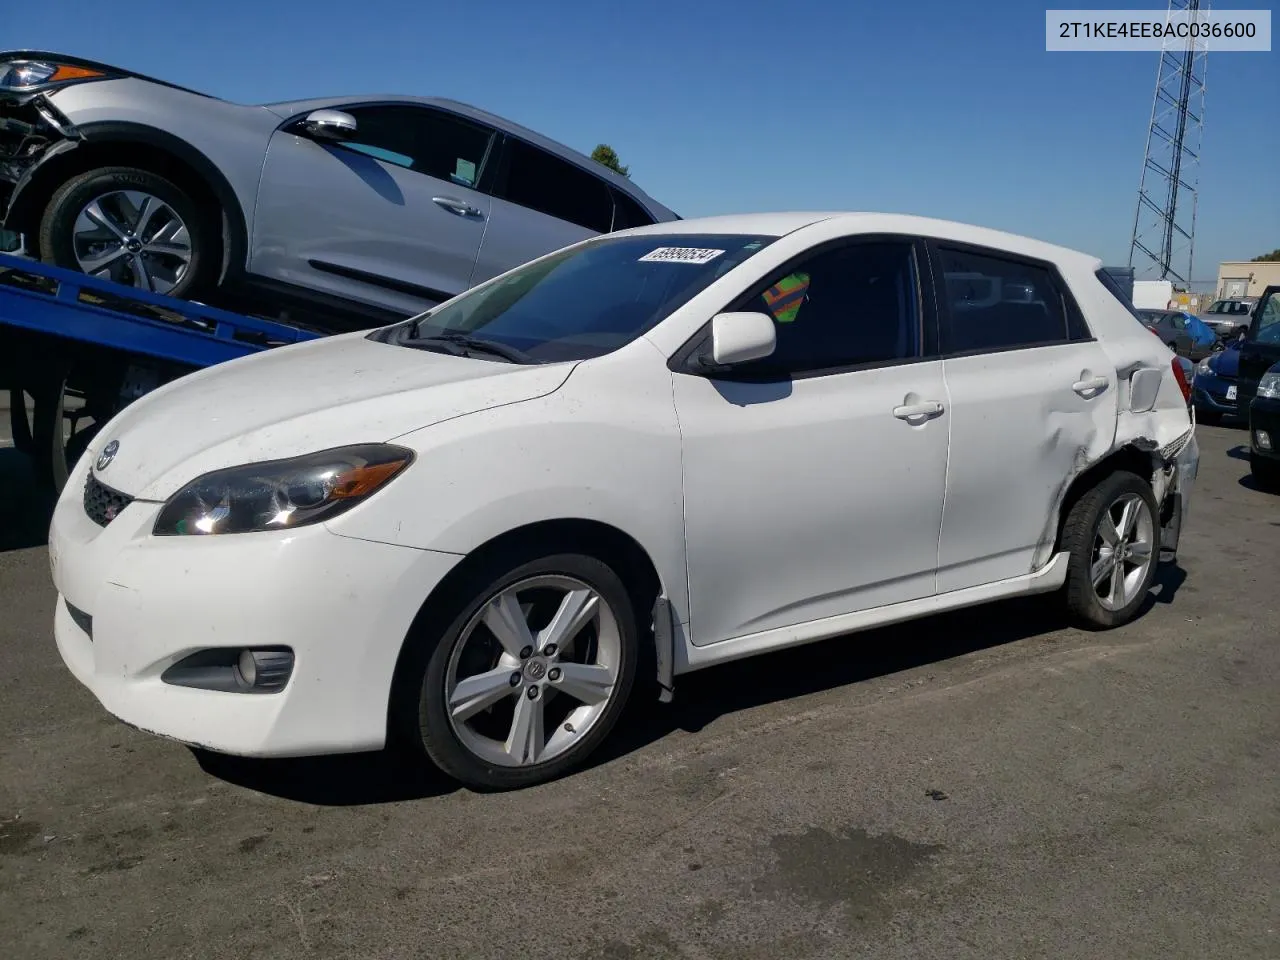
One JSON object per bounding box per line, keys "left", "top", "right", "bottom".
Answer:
{"left": 38, "top": 166, "right": 221, "bottom": 300}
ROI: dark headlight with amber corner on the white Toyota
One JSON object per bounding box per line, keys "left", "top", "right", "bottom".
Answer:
{"left": 151, "top": 443, "right": 413, "bottom": 536}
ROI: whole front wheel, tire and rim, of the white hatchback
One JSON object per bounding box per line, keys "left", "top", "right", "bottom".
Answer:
{"left": 406, "top": 554, "right": 640, "bottom": 790}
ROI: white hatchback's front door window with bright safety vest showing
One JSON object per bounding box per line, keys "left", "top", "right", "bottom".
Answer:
{"left": 733, "top": 241, "right": 920, "bottom": 378}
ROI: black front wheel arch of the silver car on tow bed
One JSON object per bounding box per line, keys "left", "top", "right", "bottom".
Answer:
{"left": 5, "top": 120, "right": 248, "bottom": 283}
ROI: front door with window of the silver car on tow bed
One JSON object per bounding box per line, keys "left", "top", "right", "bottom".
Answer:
{"left": 250, "top": 104, "right": 498, "bottom": 314}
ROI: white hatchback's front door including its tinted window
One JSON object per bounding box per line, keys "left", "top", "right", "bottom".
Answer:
{"left": 673, "top": 239, "right": 947, "bottom": 645}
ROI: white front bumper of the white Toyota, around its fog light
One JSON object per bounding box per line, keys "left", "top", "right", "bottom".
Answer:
{"left": 49, "top": 471, "right": 460, "bottom": 756}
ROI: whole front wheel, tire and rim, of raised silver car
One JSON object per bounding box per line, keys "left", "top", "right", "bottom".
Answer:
{"left": 40, "top": 166, "right": 220, "bottom": 297}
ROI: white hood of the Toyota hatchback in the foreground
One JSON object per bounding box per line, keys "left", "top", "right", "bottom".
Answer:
{"left": 91, "top": 333, "right": 575, "bottom": 500}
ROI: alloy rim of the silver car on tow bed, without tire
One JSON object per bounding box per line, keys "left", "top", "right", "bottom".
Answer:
{"left": 72, "top": 189, "right": 192, "bottom": 293}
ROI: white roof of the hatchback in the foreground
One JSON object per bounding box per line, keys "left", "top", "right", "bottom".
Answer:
{"left": 625, "top": 210, "right": 1101, "bottom": 269}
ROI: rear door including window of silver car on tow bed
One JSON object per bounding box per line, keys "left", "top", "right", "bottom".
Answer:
{"left": 471, "top": 137, "right": 613, "bottom": 284}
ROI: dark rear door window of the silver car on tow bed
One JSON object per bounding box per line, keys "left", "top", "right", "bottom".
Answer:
{"left": 498, "top": 140, "right": 613, "bottom": 233}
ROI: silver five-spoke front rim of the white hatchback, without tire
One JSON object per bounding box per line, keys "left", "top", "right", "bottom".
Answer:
{"left": 444, "top": 575, "right": 622, "bottom": 767}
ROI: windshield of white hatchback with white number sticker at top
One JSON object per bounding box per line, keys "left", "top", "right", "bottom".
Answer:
{"left": 398, "top": 233, "right": 774, "bottom": 364}
